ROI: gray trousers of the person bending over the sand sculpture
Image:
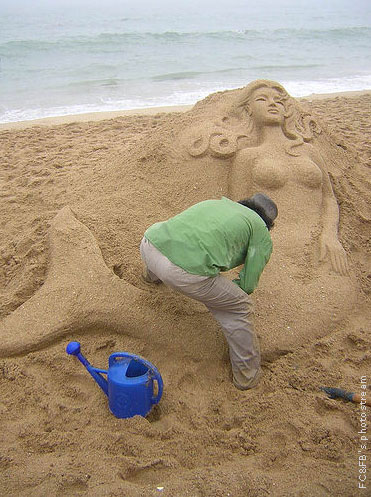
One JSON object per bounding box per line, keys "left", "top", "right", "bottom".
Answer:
{"left": 140, "top": 238, "right": 260, "bottom": 390}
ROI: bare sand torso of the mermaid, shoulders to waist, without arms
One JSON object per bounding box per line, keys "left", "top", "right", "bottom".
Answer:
{"left": 231, "top": 146, "right": 323, "bottom": 260}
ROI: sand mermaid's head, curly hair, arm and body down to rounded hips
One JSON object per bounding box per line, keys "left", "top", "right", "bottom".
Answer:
{"left": 182, "top": 80, "right": 357, "bottom": 356}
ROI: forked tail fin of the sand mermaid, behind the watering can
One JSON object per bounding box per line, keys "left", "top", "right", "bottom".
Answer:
{"left": 0, "top": 206, "right": 221, "bottom": 357}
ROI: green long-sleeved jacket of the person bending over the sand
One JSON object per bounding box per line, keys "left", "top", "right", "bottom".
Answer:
{"left": 144, "top": 197, "right": 272, "bottom": 293}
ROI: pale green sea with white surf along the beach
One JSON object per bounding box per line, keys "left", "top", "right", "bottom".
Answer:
{"left": 0, "top": 0, "right": 371, "bottom": 122}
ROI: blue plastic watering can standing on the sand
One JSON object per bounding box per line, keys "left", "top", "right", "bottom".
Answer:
{"left": 66, "top": 342, "right": 163, "bottom": 418}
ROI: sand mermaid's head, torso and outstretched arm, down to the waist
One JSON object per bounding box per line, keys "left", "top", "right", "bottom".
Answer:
{"left": 230, "top": 81, "right": 348, "bottom": 276}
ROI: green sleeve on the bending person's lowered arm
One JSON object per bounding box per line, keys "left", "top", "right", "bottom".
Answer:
{"left": 233, "top": 233, "right": 272, "bottom": 294}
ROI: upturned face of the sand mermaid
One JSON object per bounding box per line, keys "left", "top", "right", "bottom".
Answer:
{"left": 249, "top": 87, "right": 285, "bottom": 125}
